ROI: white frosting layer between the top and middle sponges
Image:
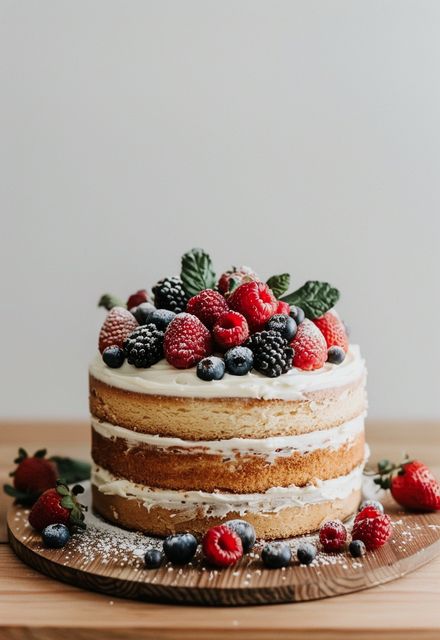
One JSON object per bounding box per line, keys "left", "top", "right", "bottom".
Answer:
{"left": 92, "top": 414, "right": 364, "bottom": 462}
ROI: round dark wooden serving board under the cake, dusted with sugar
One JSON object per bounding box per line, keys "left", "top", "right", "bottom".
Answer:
{"left": 7, "top": 488, "right": 440, "bottom": 606}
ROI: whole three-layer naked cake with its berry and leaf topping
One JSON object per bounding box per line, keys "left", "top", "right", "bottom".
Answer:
{"left": 89, "top": 250, "right": 366, "bottom": 539}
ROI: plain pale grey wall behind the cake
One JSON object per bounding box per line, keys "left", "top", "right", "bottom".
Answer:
{"left": 0, "top": 0, "right": 440, "bottom": 418}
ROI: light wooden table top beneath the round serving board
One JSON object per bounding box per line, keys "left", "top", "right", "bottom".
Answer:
{"left": 0, "top": 421, "right": 440, "bottom": 640}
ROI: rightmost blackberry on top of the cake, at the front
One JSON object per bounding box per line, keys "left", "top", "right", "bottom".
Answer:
{"left": 244, "top": 331, "right": 294, "bottom": 378}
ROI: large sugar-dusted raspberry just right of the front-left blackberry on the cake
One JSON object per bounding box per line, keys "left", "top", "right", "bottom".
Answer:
{"left": 164, "top": 313, "right": 212, "bottom": 369}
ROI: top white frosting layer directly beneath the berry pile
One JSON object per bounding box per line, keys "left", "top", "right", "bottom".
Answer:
{"left": 89, "top": 345, "right": 365, "bottom": 400}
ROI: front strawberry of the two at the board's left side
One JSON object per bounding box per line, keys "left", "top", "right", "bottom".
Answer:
{"left": 29, "top": 480, "right": 85, "bottom": 531}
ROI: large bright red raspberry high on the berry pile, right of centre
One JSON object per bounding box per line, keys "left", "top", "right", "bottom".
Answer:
{"left": 228, "top": 282, "right": 278, "bottom": 333}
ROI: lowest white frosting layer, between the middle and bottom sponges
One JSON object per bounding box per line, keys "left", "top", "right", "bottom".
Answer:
{"left": 92, "top": 456, "right": 364, "bottom": 519}
